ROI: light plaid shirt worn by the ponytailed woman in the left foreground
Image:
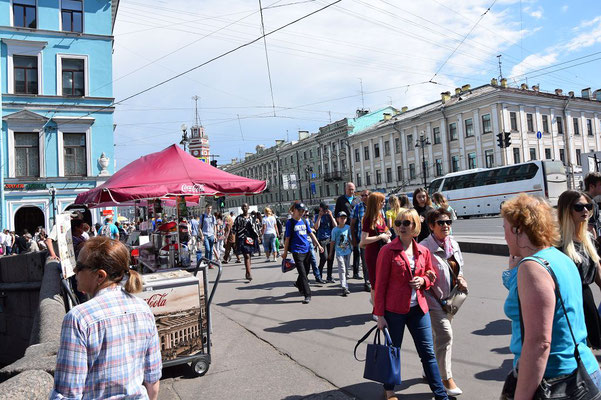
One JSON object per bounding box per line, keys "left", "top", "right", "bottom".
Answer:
{"left": 50, "top": 285, "right": 162, "bottom": 399}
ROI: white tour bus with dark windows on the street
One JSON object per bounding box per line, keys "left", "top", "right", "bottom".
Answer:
{"left": 429, "top": 161, "right": 568, "bottom": 217}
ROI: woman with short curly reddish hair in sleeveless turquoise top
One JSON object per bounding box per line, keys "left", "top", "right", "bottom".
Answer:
{"left": 501, "top": 193, "right": 601, "bottom": 400}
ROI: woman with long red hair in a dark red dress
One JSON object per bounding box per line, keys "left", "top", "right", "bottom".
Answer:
{"left": 359, "top": 192, "right": 390, "bottom": 288}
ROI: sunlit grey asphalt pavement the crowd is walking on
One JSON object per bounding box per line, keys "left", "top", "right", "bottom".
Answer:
{"left": 161, "top": 254, "right": 548, "bottom": 400}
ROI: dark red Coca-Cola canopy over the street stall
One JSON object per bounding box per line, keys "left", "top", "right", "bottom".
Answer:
{"left": 75, "top": 144, "right": 266, "bottom": 205}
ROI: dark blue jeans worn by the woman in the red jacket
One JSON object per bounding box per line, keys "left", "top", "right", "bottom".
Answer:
{"left": 384, "top": 306, "right": 448, "bottom": 400}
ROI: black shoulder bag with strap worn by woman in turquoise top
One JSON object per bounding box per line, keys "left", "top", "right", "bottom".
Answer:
{"left": 501, "top": 256, "right": 601, "bottom": 400}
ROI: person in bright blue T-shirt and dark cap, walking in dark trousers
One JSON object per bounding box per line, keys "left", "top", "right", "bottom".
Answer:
{"left": 282, "top": 202, "right": 323, "bottom": 304}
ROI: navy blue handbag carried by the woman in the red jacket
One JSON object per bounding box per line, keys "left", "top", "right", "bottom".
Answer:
{"left": 354, "top": 326, "right": 401, "bottom": 385}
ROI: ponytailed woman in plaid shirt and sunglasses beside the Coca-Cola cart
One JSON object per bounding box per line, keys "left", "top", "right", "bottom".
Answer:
{"left": 50, "top": 236, "right": 162, "bottom": 399}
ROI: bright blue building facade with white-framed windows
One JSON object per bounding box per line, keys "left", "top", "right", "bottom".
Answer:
{"left": 0, "top": 0, "right": 118, "bottom": 233}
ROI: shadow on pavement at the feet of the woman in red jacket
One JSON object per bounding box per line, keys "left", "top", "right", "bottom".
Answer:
{"left": 283, "top": 379, "right": 433, "bottom": 400}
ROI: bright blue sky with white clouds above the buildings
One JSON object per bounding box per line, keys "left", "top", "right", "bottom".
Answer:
{"left": 108, "top": 0, "right": 601, "bottom": 168}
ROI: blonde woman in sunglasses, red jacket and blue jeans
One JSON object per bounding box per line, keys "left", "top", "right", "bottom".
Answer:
{"left": 374, "top": 209, "right": 448, "bottom": 400}
